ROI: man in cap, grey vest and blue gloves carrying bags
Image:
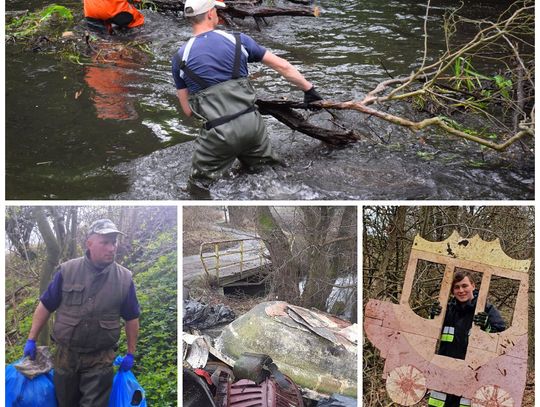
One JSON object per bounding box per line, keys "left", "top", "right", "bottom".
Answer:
{"left": 24, "top": 219, "right": 140, "bottom": 407}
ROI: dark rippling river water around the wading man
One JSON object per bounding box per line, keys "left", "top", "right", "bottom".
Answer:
{"left": 6, "top": 0, "right": 534, "bottom": 200}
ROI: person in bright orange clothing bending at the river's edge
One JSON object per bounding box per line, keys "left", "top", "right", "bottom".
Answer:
{"left": 84, "top": 0, "right": 144, "bottom": 33}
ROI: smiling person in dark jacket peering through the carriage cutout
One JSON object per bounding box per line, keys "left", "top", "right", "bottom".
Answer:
{"left": 428, "top": 270, "right": 506, "bottom": 407}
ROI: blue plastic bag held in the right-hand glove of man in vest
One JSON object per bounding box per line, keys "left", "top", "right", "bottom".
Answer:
{"left": 109, "top": 356, "right": 147, "bottom": 407}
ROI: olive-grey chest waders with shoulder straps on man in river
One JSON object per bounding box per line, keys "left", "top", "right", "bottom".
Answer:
{"left": 180, "top": 33, "right": 278, "bottom": 186}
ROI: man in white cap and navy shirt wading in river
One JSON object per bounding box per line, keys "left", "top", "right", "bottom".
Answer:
{"left": 172, "top": 0, "right": 322, "bottom": 196}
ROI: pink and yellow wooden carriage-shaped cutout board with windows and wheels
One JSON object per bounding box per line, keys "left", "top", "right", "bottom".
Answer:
{"left": 364, "top": 232, "right": 531, "bottom": 407}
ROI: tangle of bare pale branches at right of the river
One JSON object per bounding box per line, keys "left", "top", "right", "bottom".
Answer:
{"left": 318, "top": 0, "right": 535, "bottom": 151}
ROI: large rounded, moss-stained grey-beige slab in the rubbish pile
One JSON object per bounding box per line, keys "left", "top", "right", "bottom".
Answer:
{"left": 216, "top": 302, "right": 357, "bottom": 397}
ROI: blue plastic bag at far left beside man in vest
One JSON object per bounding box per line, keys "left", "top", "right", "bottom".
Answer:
{"left": 6, "top": 359, "right": 58, "bottom": 407}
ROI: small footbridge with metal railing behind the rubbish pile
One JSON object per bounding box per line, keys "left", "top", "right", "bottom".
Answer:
{"left": 199, "top": 238, "right": 269, "bottom": 284}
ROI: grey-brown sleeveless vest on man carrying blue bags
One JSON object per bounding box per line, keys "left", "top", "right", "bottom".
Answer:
{"left": 53, "top": 257, "right": 131, "bottom": 353}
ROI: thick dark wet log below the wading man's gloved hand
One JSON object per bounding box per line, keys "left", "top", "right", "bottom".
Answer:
{"left": 256, "top": 99, "right": 360, "bottom": 146}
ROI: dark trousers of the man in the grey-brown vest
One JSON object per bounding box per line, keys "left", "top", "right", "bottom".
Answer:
{"left": 54, "top": 346, "right": 115, "bottom": 407}
